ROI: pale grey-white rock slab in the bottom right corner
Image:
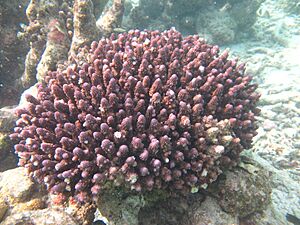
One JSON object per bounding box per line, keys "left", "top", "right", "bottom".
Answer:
{"left": 242, "top": 151, "right": 300, "bottom": 225}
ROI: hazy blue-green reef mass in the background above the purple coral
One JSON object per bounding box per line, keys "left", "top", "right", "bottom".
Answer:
{"left": 123, "top": 0, "right": 264, "bottom": 45}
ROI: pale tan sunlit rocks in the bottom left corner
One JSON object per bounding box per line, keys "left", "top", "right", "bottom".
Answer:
{"left": 0, "top": 167, "right": 95, "bottom": 225}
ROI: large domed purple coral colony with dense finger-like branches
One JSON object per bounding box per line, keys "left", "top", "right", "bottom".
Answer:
{"left": 11, "top": 29, "right": 259, "bottom": 202}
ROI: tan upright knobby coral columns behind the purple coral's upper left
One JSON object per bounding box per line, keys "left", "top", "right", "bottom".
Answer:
{"left": 18, "top": 0, "right": 124, "bottom": 91}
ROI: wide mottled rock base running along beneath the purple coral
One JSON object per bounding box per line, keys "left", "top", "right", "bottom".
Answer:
{"left": 97, "top": 157, "right": 271, "bottom": 225}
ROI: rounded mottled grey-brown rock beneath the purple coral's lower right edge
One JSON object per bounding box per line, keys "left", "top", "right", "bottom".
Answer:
{"left": 218, "top": 156, "right": 271, "bottom": 218}
